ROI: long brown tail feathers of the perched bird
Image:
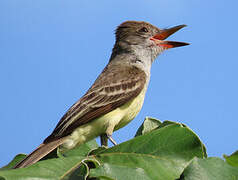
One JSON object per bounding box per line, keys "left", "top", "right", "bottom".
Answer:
{"left": 14, "top": 138, "right": 64, "bottom": 169}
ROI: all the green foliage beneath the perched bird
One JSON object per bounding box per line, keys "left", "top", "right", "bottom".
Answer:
{"left": 0, "top": 118, "right": 238, "bottom": 180}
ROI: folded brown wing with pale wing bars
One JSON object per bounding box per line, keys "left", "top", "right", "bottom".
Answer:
{"left": 44, "top": 65, "right": 146, "bottom": 143}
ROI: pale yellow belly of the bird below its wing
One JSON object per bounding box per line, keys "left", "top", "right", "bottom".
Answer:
{"left": 62, "top": 87, "right": 146, "bottom": 149}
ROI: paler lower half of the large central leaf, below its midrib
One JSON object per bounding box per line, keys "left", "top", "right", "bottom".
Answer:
{"left": 90, "top": 153, "right": 182, "bottom": 180}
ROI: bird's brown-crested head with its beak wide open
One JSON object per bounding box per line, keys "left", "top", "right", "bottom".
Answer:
{"left": 113, "top": 21, "right": 188, "bottom": 62}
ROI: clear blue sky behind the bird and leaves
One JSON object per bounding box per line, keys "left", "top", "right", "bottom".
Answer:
{"left": 0, "top": 0, "right": 238, "bottom": 166}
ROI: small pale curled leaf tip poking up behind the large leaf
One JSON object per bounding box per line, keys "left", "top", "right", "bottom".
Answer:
{"left": 135, "top": 117, "right": 162, "bottom": 137}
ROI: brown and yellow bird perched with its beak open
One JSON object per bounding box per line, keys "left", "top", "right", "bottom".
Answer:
{"left": 14, "top": 21, "right": 189, "bottom": 169}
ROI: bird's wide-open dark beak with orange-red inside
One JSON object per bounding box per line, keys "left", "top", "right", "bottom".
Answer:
{"left": 150, "top": 25, "right": 189, "bottom": 49}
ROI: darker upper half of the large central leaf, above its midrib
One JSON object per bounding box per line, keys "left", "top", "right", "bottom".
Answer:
{"left": 101, "top": 124, "right": 204, "bottom": 160}
